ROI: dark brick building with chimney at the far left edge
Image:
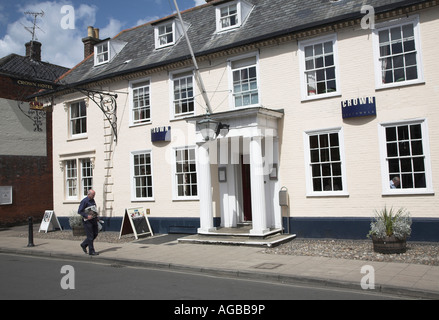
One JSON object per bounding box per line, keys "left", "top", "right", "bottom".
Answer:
{"left": 0, "top": 41, "right": 68, "bottom": 225}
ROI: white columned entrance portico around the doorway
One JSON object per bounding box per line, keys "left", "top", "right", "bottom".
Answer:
{"left": 189, "top": 108, "right": 284, "bottom": 236}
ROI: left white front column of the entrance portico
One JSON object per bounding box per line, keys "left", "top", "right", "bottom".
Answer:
{"left": 197, "top": 143, "right": 216, "bottom": 233}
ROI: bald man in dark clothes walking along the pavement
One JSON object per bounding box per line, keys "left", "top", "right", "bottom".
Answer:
{"left": 78, "top": 189, "right": 98, "bottom": 256}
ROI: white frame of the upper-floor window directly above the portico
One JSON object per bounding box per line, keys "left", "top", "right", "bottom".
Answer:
{"left": 228, "top": 53, "right": 262, "bottom": 110}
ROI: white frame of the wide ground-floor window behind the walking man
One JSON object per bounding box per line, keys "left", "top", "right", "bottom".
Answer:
{"left": 62, "top": 157, "right": 95, "bottom": 201}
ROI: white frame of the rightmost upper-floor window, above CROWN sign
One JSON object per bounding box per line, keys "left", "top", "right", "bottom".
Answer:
{"left": 372, "top": 15, "right": 424, "bottom": 90}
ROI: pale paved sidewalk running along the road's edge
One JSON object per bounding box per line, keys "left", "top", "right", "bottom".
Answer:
{"left": 0, "top": 227, "right": 439, "bottom": 299}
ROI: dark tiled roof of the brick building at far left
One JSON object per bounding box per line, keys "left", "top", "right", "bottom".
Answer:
{"left": 0, "top": 53, "right": 69, "bottom": 82}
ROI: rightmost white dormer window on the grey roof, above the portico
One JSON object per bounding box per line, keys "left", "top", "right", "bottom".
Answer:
{"left": 216, "top": 0, "right": 253, "bottom": 32}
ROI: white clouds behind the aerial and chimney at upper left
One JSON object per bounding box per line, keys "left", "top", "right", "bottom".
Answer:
{"left": 0, "top": 0, "right": 122, "bottom": 68}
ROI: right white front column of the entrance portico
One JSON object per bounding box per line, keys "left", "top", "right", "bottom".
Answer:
{"left": 249, "top": 137, "right": 270, "bottom": 235}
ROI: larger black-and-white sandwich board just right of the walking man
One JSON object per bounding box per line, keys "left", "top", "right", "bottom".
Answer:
{"left": 119, "top": 208, "right": 154, "bottom": 240}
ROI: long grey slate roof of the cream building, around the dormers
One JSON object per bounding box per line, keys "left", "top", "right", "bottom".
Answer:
{"left": 57, "top": 0, "right": 425, "bottom": 85}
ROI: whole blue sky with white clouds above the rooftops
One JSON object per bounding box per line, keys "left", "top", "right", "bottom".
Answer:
{"left": 0, "top": 0, "right": 206, "bottom": 68}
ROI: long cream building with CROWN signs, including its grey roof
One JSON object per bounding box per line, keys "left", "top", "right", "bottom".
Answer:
{"left": 44, "top": 0, "right": 439, "bottom": 241}
